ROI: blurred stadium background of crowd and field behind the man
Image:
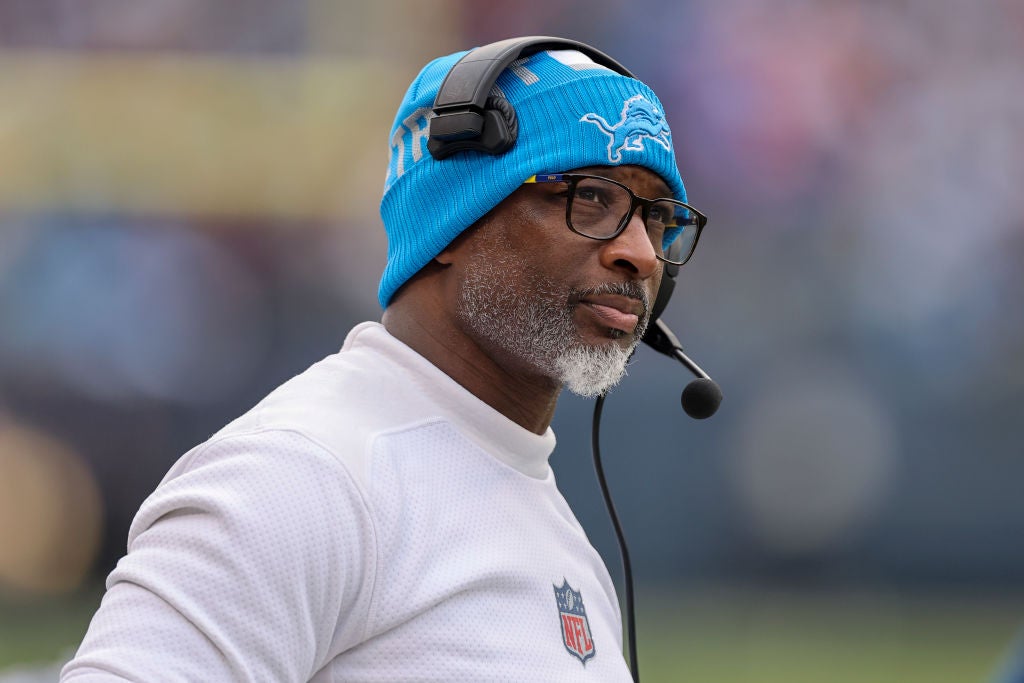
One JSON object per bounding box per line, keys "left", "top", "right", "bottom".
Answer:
{"left": 0, "top": 0, "right": 1024, "bottom": 683}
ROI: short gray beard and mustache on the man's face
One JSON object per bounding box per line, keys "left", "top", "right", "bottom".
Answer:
{"left": 457, "top": 250, "right": 647, "bottom": 398}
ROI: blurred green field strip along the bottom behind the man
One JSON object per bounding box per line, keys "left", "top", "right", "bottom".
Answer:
{"left": 0, "top": 587, "right": 1024, "bottom": 683}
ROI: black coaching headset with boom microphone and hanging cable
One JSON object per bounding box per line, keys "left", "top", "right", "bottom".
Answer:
{"left": 427, "top": 36, "right": 722, "bottom": 682}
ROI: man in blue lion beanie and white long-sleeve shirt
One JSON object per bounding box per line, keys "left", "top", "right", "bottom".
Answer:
{"left": 62, "top": 38, "right": 699, "bottom": 683}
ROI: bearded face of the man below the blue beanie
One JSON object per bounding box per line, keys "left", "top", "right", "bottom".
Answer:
{"left": 448, "top": 166, "right": 671, "bottom": 396}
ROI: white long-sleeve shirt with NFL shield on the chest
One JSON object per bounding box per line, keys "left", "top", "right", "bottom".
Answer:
{"left": 61, "top": 323, "right": 630, "bottom": 683}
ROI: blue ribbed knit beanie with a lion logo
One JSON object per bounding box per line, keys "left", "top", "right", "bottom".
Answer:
{"left": 378, "top": 45, "right": 686, "bottom": 307}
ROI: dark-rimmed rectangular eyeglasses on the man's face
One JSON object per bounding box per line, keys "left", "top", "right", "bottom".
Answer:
{"left": 523, "top": 173, "right": 708, "bottom": 265}
